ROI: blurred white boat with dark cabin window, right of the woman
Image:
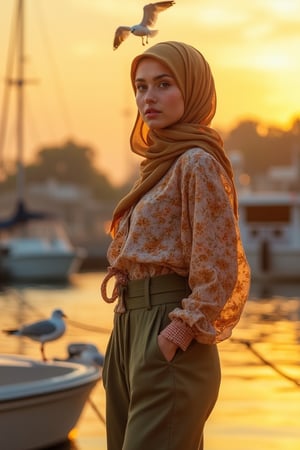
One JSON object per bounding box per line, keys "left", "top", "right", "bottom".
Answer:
{"left": 239, "top": 192, "right": 300, "bottom": 280}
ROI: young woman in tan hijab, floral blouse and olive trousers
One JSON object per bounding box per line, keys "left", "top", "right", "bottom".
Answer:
{"left": 102, "top": 42, "right": 250, "bottom": 450}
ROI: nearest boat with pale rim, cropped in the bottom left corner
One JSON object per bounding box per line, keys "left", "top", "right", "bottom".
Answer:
{"left": 0, "top": 355, "right": 100, "bottom": 450}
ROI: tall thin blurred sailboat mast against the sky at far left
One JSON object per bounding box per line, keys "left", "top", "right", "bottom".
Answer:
{"left": 16, "top": 0, "right": 25, "bottom": 202}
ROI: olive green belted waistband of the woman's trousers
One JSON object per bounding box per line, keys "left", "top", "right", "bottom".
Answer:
{"left": 120, "top": 273, "right": 191, "bottom": 310}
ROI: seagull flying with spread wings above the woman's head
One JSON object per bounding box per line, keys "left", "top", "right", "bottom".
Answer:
{"left": 114, "top": 2, "right": 175, "bottom": 50}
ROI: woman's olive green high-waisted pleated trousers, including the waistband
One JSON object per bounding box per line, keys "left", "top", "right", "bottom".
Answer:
{"left": 103, "top": 275, "right": 221, "bottom": 450}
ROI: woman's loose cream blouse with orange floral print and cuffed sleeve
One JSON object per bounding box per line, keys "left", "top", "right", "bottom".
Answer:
{"left": 103, "top": 148, "right": 250, "bottom": 350}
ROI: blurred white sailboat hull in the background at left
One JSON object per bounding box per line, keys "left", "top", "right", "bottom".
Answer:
{"left": 0, "top": 220, "right": 85, "bottom": 281}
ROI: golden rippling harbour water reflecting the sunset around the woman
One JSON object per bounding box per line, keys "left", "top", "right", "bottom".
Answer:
{"left": 0, "top": 274, "right": 300, "bottom": 450}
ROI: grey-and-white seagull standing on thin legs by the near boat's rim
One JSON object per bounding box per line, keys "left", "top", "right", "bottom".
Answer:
{"left": 3, "top": 309, "right": 66, "bottom": 361}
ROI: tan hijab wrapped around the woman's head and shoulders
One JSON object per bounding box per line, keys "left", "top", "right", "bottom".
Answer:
{"left": 111, "top": 41, "right": 237, "bottom": 235}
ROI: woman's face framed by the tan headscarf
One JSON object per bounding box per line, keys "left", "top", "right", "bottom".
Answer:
{"left": 135, "top": 57, "right": 184, "bottom": 129}
